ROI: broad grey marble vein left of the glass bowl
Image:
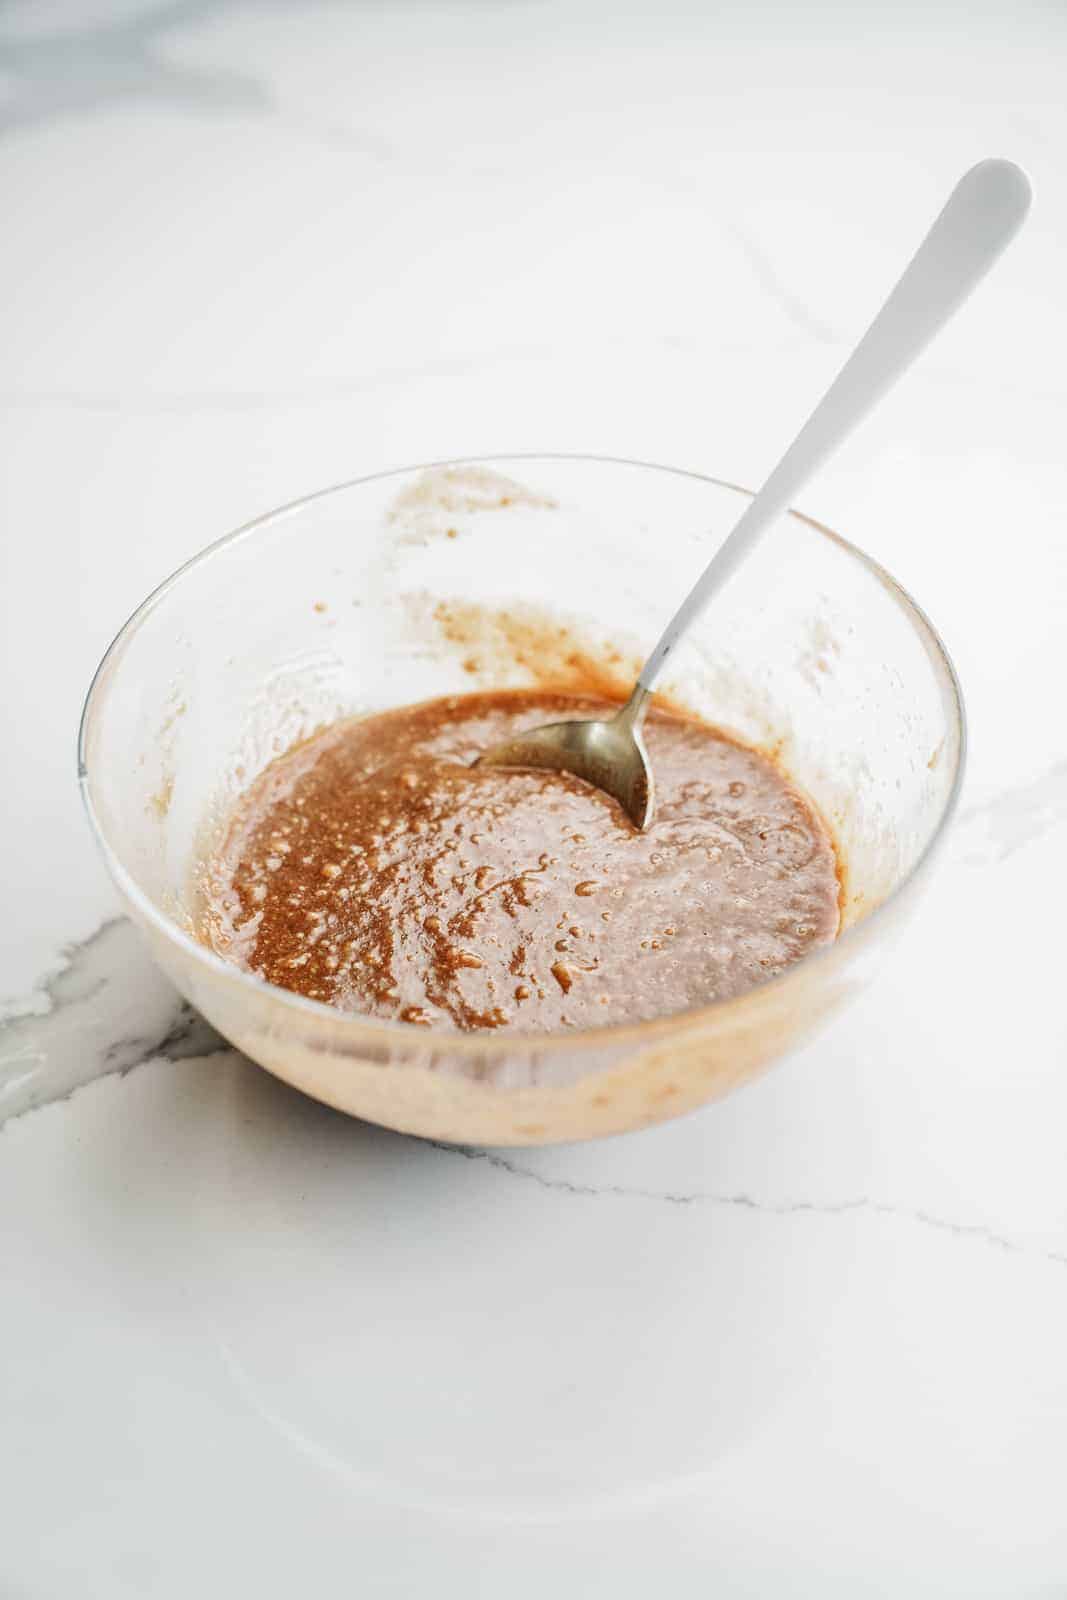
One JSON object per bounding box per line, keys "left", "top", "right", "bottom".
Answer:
{"left": 0, "top": 917, "right": 230, "bottom": 1126}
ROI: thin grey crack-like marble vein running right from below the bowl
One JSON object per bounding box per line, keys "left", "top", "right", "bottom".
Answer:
{"left": 426, "top": 1139, "right": 1067, "bottom": 1267}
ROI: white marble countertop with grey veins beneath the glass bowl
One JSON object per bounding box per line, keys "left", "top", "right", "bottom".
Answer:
{"left": 0, "top": 0, "right": 1067, "bottom": 1600}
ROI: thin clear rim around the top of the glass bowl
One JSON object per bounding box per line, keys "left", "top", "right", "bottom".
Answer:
{"left": 77, "top": 450, "right": 968, "bottom": 1058}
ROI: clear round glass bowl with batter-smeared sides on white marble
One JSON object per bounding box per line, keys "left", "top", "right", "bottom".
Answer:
{"left": 78, "top": 456, "right": 965, "bottom": 1144}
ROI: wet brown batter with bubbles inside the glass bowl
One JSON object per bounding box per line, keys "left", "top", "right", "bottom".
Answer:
{"left": 203, "top": 691, "right": 838, "bottom": 1032}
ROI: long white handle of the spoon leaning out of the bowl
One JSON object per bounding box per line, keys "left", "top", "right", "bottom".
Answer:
{"left": 638, "top": 160, "right": 1030, "bottom": 690}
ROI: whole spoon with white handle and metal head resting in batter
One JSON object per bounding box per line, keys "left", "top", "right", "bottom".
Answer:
{"left": 475, "top": 160, "right": 1030, "bottom": 832}
